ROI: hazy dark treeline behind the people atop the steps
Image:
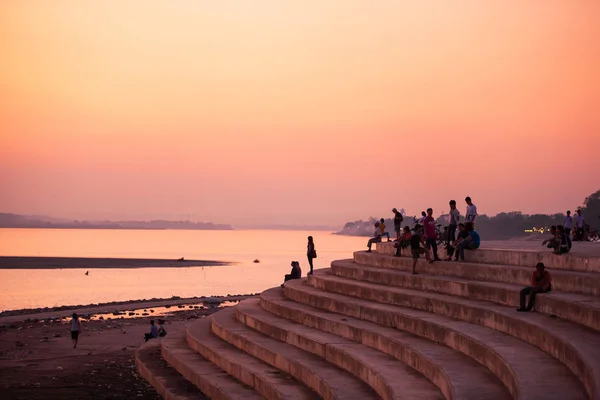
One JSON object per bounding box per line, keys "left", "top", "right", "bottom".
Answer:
{"left": 338, "top": 190, "right": 600, "bottom": 240}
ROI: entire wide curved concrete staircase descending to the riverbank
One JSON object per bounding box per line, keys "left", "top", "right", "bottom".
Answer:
{"left": 136, "top": 243, "right": 600, "bottom": 400}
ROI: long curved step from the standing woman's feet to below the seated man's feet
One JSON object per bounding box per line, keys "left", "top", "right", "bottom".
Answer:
{"left": 308, "top": 270, "right": 600, "bottom": 398}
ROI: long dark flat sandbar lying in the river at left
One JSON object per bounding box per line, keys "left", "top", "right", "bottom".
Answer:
{"left": 0, "top": 256, "right": 233, "bottom": 269}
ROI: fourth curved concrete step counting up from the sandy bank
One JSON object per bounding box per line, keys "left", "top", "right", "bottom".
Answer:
{"left": 212, "top": 302, "right": 379, "bottom": 400}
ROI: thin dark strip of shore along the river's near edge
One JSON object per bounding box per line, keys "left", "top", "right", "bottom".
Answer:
{"left": 0, "top": 293, "right": 259, "bottom": 324}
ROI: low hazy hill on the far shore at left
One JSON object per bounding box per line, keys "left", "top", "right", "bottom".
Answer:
{"left": 0, "top": 213, "right": 233, "bottom": 230}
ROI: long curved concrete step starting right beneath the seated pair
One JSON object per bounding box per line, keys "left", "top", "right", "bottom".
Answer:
{"left": 284, "top": 280, "right": 593, "bottom": 400}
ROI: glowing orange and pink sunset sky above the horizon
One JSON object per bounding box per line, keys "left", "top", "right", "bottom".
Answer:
{"left": 0, "top": 0, "right": 600, "bottom": 225}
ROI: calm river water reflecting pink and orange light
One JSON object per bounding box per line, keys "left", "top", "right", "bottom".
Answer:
{"left": 0, "top": 229, "right": 367, "bottom": 311}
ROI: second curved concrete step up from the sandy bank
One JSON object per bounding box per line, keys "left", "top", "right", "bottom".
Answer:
{"left": 161, "top": 334, "right": 264, "bottom": 400}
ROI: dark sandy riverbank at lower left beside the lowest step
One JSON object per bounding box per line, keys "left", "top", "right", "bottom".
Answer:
{"left": 0, "top": 302, "right": 224, "bottom": 400}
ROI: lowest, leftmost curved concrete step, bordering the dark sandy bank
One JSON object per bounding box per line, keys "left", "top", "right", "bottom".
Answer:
{"left": 135, "top": 341, "right": 208, "bottom": 400}
